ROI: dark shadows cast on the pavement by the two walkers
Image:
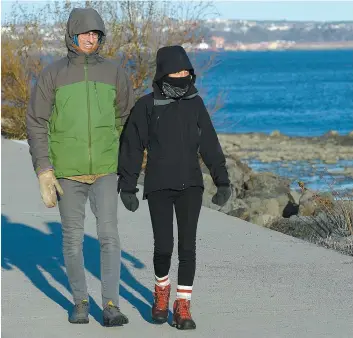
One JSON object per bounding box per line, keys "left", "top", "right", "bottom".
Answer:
{"left": 1, "top": 214, "right": 169, "bottom": 323}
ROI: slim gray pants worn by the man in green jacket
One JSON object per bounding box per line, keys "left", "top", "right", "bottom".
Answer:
{"left": 58, "top": 174, "right": 121, "bottom": 306}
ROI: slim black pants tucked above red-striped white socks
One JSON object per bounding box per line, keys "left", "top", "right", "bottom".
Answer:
{"left": 147, "top": 187, "right": 203, "bottom": 286}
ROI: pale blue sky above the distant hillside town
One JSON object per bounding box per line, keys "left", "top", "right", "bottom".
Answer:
{"left": 1, "top": 0, "right": 353, "bottom": 21}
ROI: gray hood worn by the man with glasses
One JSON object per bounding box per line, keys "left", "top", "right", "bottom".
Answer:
{"left": 65, "top": 8, "right": 106, "bottom": 57}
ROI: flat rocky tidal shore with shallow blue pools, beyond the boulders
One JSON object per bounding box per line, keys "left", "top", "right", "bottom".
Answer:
{"left": 219, "top": 131, "right": 353, "bottom": 196}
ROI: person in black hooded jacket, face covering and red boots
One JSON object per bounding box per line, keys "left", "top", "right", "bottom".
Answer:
{"left": 118, "top": 46, "right": 231, "bottom": 329}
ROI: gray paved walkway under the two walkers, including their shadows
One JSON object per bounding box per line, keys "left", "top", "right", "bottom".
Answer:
{"left": 1, "top": 140, "right": 353, "bottom": 338}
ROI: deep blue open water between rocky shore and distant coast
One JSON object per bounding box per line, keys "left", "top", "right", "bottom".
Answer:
{"left": 192, "top": 50, "right": 353, "bottom": 136}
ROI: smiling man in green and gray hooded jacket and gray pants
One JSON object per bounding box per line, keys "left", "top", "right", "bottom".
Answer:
{"left": 27, "top": 8, "right": 134, "bottom": 326}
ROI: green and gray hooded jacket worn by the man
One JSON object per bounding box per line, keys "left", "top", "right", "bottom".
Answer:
{"left": 27, "top": 8, "right": 134, "bottom": 178}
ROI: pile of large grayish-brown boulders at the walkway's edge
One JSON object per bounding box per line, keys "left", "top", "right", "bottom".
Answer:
{"left": 203, "top": 158, "right": 299, "bottom": 226}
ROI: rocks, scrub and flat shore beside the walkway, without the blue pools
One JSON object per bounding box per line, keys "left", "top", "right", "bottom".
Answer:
{"left": 139, "top": 132, "right": 353, "bottom": 255}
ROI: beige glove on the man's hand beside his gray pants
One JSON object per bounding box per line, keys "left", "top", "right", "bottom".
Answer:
{"left": 38, "top": 170, "right": 64, "bottom": 208}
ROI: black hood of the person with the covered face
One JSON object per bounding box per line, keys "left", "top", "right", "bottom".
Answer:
{"left": 153, "top": 46, "right": 195, "bottom": 82}
